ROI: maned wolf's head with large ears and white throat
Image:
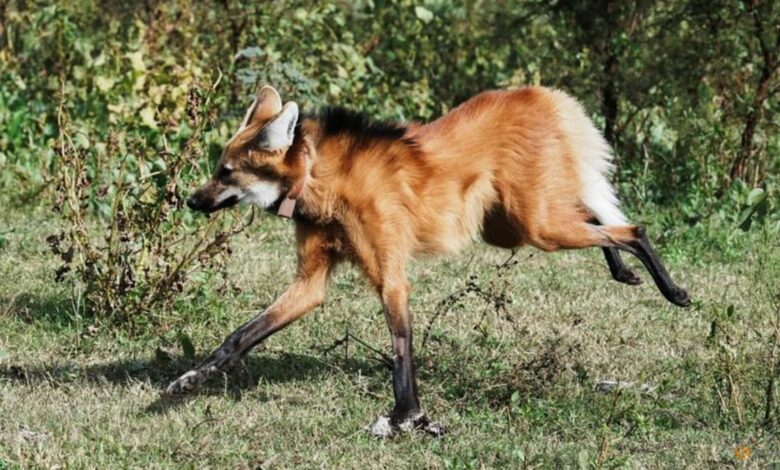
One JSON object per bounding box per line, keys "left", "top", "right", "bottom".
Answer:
{"left": 187, "top": 86, "right": 307, "bottom": 213}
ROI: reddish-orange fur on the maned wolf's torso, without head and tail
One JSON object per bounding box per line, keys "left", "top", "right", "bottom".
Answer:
{"left": 290, "top": 88, "right": 630, "bottom": 280}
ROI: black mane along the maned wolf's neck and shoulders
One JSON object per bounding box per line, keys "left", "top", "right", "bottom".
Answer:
{"left": 319, "top": 107, "right": 406, "bottom": 139}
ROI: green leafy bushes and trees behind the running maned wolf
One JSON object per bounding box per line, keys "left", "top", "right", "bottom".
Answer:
{"left": 0, "top": 0, "right": 780, "bottom": 308}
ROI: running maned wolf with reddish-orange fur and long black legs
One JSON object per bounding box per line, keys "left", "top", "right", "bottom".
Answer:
{"left": 168, "top": 86, "right": 690, "bottom": 436}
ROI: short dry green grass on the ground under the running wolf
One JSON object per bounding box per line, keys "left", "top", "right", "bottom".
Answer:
{"left": 0, "top": 209, "right": 780, "bottom": 469}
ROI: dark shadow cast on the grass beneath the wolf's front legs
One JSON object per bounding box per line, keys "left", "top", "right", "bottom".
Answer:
{"left": 0, "top": 351, "right": 385, "bottom": 414}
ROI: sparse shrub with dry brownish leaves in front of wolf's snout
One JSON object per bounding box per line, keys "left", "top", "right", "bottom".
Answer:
{"left": 47, "top": 81, "right": 251, "bottom": 321}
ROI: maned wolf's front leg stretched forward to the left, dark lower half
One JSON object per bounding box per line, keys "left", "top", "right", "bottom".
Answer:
{"left": 166, "top": 229, "right": 334, "bottom": 394}
